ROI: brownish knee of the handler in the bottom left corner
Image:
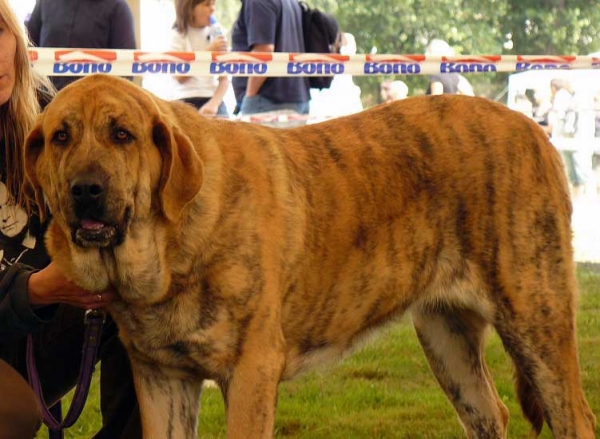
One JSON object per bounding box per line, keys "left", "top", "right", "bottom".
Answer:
{"left": 0, "top": 359, "right": 42, "bottom": 439}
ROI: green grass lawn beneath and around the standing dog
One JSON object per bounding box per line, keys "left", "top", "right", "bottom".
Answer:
{"left": 38, "top": 268, "right": 600, "bottom": 439}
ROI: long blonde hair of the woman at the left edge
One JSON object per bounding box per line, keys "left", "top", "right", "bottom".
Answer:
{"left": 0, "top": 0, "right": 54, "bottom": 208}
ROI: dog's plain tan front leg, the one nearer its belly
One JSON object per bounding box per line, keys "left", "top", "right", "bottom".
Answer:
{"left": 223, "top": 345, "right": 285, "bottom": 439}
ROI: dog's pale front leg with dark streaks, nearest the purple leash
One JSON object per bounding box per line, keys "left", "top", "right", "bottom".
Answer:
{"left": 131, "top": 359, "right": 202, "bottom": 439}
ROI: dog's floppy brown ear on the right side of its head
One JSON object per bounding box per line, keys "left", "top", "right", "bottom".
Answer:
{"left": 152, "top": 120, "right": 204, "bottom": 222}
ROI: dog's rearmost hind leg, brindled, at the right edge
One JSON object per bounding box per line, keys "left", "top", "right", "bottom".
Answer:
{"left": 495, "top": 276, "right": 595, "bottom": 439}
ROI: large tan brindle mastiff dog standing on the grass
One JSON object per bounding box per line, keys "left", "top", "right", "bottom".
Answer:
{"left": 26, "top": 76, "right": 595, "bottom": 439}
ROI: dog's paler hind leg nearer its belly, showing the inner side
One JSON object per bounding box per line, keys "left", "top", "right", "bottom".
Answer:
{"left": 412, "top": 306, "right": 508, "bottom": 439}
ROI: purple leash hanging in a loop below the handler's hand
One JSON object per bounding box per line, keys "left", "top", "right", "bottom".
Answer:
{"left": 27, "top": 309, "right": 105, "bottom": 439}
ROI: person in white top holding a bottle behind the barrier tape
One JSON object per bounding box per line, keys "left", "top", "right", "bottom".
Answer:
{"left": 168, "top": 0, "right": 229, "bottom": 117}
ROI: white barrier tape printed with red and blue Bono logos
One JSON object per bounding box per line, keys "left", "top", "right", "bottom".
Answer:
{"left": 29, "top": 48, "right": 600, "bottom": 76}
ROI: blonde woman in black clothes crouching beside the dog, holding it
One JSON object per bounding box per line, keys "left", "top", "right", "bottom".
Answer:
{"left": 0, "top": 0, "right": 141, "bottom": 439}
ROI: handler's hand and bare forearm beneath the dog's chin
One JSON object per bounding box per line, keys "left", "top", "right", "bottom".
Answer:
{"left": 27, "top": 262, "right": 116, "bottom": 309}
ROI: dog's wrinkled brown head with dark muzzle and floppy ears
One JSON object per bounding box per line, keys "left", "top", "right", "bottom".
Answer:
{"left": 25, "top": 75, "right": 203, "bottom": 248}
